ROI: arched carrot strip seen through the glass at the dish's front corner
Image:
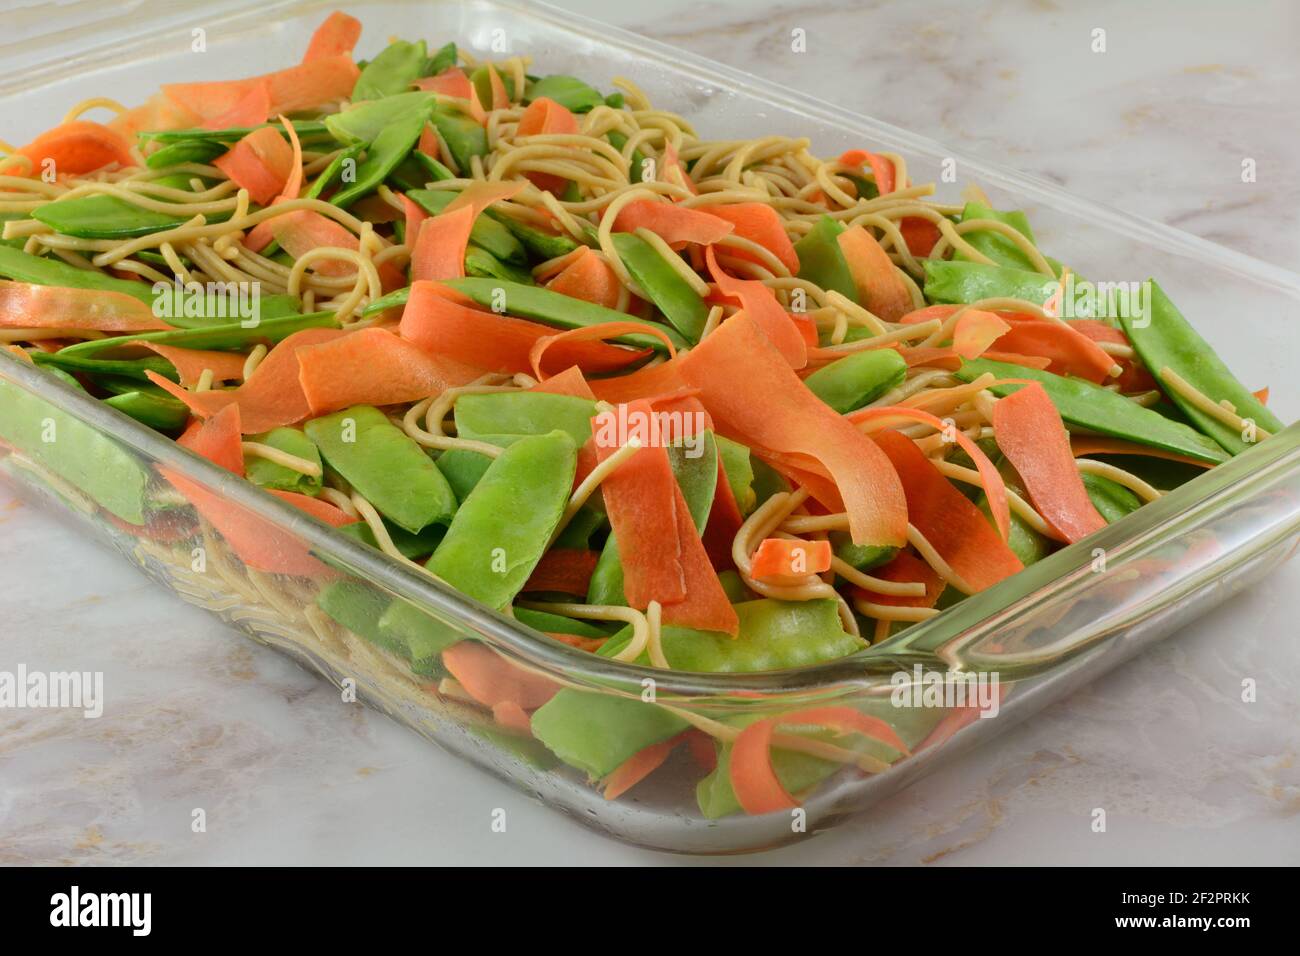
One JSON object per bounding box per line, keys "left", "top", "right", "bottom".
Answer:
{"left": 731, "top": 706, "right": 910, "bottom": 814}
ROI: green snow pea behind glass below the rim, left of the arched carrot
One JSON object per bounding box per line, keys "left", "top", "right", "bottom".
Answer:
{"left": 532, "top": 688, "right": 690, "bottom": 779}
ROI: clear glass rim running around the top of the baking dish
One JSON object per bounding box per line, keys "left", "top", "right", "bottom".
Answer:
{"left": 0, "top": 0, "right": 1300, "bottom": 696}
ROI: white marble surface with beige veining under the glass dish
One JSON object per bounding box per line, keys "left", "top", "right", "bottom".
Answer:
{"left": 0, "top": 0, "right": 1300, "bottom": 865}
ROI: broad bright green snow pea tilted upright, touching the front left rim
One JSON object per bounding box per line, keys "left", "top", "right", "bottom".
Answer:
{"left": 425, "top": 431, "right": 577, "bottom": 609}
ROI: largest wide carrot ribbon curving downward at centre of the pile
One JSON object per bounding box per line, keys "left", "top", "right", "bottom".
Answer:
{"left": 676, "top": 315, "right": 907, "bottom": 546}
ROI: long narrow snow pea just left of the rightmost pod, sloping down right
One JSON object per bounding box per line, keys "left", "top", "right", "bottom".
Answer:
{"left": 957, "top": 359, "right": 1229, "bottom": 464}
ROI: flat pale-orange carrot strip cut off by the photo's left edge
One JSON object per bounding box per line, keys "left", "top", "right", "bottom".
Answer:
{"left": 0, "top": 280, "right": 172, "bottom": 332}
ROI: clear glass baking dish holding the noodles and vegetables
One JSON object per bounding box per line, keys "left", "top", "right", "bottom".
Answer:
{"left": 0, "top": 0, "right": 1300, "bottom": 853}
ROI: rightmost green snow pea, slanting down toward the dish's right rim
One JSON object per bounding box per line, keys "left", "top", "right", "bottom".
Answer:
{"left": 1119, "top": 280, "right": 1284, "bottom": 455}
